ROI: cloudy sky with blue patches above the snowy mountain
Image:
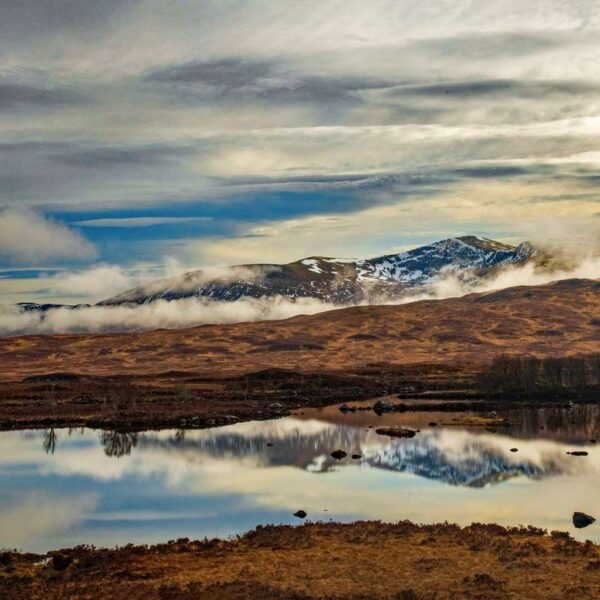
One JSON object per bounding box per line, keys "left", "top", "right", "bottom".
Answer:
{"left": 0, "top": 0, "right": 600, "bottom": 303}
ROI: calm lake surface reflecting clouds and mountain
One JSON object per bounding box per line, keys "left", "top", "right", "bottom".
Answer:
{"left": 0, "top": 405, "right": 600, "bottom": 551}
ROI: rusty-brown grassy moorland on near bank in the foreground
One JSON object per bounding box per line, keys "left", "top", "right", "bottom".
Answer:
{"left": 0, "top": 522, "right": 600, "bottom": 600}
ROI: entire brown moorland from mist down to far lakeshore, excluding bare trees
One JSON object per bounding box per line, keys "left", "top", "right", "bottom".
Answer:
{"left": 0, "top": 279, "right": 600, "bottom": 429}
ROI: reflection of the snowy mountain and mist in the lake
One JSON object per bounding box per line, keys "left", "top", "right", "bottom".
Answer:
{"left": 134, "top": 419, "right": 575, "bottom": 487}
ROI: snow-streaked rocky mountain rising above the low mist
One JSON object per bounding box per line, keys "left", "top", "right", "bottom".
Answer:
{"left": 99, "top": 236, "right": 535, "bottom": 305}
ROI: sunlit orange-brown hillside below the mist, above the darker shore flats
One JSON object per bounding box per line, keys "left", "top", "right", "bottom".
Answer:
{"left": 0, "top": 280, "right": 600, "bottom": 381}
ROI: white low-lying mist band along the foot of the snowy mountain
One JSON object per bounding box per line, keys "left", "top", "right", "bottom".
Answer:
{"left": 0, "top": 257, "right": 600, "bottom": 336}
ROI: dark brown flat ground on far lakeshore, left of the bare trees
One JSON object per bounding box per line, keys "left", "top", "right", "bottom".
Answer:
{"left": 0, "top": 365, "right": 465, "bottom": 430}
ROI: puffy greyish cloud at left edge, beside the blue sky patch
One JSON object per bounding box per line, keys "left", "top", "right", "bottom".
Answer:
{"left": 0, "top": 208, "right": 96, "bottom": 264}
